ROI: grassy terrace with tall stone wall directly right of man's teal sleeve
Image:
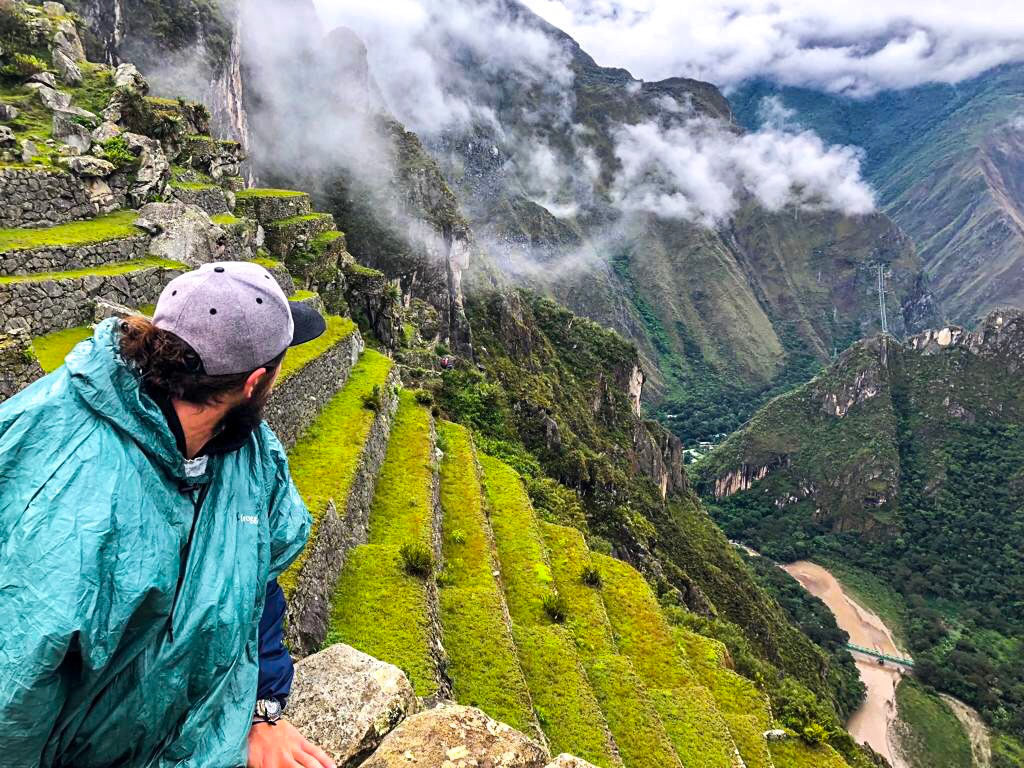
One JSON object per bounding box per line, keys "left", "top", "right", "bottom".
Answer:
{"left": 286, "top": 349, "right": 397, "bottom": 655}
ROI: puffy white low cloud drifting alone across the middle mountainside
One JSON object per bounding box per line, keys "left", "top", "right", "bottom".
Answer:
{"left": 612, "top": 118, "right": 874, "bottom": 226}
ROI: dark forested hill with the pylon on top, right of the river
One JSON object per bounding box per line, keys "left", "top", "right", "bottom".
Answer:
{"left": 697, "top": 310, "right": 1024, "bottom": 761}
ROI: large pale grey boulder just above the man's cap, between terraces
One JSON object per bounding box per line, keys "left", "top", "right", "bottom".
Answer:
{"left": 135, "top": 202, "right": 227, "bottom": 267}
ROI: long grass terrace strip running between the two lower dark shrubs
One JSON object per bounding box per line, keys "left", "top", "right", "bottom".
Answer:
{"left": 437, "top": 422, "right": 535, "bottom": 732}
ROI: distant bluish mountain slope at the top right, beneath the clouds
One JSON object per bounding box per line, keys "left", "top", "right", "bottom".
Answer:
{"left": 729, "top": 65, "right": 1024, "bottom": 324}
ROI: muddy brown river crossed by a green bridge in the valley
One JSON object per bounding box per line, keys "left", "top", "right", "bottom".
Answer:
{"left": 782, "top": 560, "right": 909, "bottom": 768}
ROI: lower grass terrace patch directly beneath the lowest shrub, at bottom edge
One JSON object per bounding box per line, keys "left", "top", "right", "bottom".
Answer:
{"left": 512, "top": 625, "right": 621, "bottom": 768}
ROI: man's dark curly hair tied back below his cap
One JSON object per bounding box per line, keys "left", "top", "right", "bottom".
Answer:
{"left": 120, "top": 315, "right": 287, "bottom": 406}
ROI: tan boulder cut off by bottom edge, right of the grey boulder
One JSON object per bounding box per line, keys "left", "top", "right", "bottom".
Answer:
{"left": 362, "top": 705, "right": 549, "bottom": 768}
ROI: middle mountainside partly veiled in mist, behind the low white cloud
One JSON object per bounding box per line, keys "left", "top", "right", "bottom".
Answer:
{"left": 411, "top": 2, "right": 936, "bottom": 439}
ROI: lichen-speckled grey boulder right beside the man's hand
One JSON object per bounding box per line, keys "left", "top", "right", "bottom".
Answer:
{"left": 288, "top": 644, "right": 417, "bottom": 766}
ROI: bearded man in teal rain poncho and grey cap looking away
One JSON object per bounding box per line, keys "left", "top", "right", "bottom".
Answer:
{"left": 0, "top": 262, "right": 333, "bottom": 768}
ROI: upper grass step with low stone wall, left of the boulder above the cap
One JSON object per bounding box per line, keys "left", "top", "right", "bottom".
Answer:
{"left": 0, "top": 211, "right": 150, "bottom": 275}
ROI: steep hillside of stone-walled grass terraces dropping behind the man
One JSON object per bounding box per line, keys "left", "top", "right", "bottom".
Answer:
{"left": 0, "top": 3, "right": 870, "bottom": 768}
